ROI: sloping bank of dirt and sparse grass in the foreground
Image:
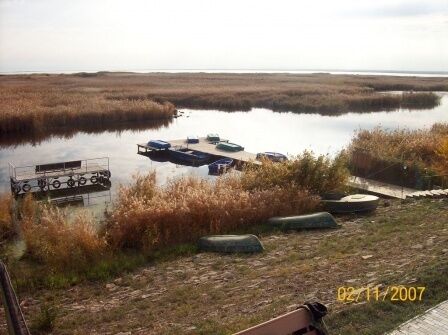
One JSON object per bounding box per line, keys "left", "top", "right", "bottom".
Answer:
{"left": 3, "top": 200, "right": 448, "bottom": 334}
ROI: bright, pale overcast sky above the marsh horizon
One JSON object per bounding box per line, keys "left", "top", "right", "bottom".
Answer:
{"left": 0, "top": 0, "right": 448, "bottom": 72}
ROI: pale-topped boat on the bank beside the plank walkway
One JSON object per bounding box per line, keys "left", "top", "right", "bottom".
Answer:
{"left": 322, "top": 194, "right": 380, "bottom": 214}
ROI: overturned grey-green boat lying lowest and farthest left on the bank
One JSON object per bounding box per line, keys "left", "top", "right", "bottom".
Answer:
{"left": 198, "top": 235, "right": 264, "bottom": 253}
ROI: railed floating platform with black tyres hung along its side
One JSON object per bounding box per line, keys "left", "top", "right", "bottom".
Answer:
{"left": 9, "top": 157, "right": 111, "bottom": 196}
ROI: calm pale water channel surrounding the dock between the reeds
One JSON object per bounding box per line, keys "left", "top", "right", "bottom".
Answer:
{"left": 0, "top": 93, "right": 448, "bottom": 202}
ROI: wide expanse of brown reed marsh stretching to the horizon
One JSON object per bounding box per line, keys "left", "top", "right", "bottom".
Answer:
{"left": 0, "top": 73, "right": 448, "bottom": 142}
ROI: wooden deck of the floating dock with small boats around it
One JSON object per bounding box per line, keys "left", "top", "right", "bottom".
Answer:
{"left": 137, "top": 137, "right": 259, "bottom": 164}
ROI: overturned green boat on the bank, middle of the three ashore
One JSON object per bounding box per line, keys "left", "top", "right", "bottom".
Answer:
{"left": 268, "top": 212, "right": 339, "bottom": 230}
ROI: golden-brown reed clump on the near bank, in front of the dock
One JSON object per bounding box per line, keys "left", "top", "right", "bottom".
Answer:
{"left": 105, "top": 173, "right": 318, "bottom": 251}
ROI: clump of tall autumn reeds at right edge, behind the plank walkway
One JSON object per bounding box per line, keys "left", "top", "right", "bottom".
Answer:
{"left": 349, "top": 123, "right": 448, "bottom": 189}
